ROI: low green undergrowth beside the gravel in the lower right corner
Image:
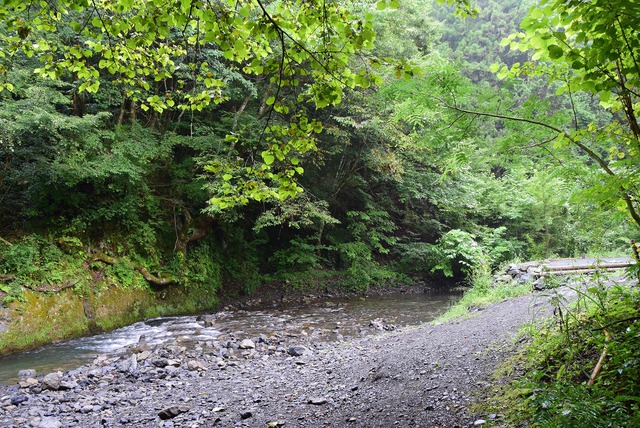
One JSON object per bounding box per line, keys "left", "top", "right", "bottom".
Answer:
{"left": 489, "top": 276, "right": 640, "bottom": 428}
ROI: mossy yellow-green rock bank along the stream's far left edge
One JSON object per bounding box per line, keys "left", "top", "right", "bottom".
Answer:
{"left": 0, "top": 286, "right": 217, "bottom": 355}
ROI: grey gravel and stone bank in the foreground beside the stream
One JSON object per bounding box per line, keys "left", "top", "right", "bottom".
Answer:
{"left": 0, "top": 295, "right": 549, "bottom": 428}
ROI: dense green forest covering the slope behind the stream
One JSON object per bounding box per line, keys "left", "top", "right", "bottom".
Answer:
{"left": 0, "top": 0, "right": 640, "bottom": 426}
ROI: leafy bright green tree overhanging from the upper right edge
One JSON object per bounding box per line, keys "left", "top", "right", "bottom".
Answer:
{"left": 460, "top": 0, "right": 640, "bottom": 231}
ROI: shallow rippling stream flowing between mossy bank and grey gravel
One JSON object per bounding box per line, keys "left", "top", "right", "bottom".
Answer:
{"left": 0, "top": 290, "right": 461, "bottom": 384}
